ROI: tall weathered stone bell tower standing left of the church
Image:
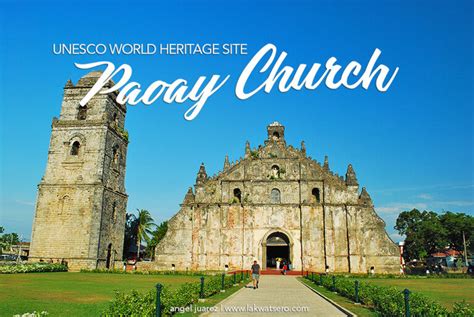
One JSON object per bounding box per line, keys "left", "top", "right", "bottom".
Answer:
{"left": 29, "top": 72, "right": 128, "bottom": 270}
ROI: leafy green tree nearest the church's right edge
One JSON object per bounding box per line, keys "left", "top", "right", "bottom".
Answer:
{"left": 395, "top": 209, "right": 449, "bottom": 261}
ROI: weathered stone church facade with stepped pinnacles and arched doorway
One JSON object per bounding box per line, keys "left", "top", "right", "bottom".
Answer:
{"left": 154, "top": 122, "right": 399, "bottom": 273}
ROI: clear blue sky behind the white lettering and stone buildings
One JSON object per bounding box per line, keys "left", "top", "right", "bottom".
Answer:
{"left": 0, "top": 1, "right": 474, "bottom": 240}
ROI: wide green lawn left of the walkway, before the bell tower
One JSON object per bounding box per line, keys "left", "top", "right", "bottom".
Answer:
{"left": 0, "top": 272, "right": 199, "bottom": 316}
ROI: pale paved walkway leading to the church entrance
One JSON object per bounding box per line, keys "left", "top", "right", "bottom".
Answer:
{"left": 204, "top": 275, "right": 346, "bottom": 317}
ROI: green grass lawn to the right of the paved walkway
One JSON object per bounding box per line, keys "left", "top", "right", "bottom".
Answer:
{"left": 359, "top": 278, "right": 474, "bottom": 309}
